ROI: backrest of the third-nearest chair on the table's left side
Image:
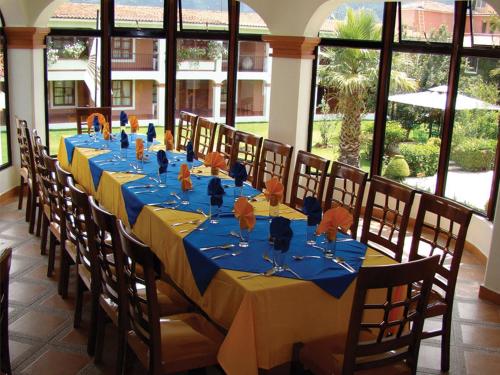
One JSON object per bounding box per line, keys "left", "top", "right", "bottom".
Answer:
{"left": 68, "top": 181, "right": 99, "bottom": 288}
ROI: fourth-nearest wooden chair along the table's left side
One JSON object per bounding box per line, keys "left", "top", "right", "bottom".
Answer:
{"left": 56, "top": 163, "right": 78, "bottom": 298}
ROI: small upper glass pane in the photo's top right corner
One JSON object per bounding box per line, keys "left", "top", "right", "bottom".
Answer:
{"left": 464, "top": 0, "right": 500, "bottom": 47}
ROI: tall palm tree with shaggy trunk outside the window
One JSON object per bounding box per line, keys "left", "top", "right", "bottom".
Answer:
{"left": 319, "top": 9, "right": 416, "bottom": 167}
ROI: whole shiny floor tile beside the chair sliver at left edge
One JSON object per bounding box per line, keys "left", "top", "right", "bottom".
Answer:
{"left": 9, "top": 311, "right": 66, "bottom": 340}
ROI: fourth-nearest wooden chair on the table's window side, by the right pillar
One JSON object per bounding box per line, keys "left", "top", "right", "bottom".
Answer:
{"left": 290, "top": 150, "right": 330, "bottom": 208}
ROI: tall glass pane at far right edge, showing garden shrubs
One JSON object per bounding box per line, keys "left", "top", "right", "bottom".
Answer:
{"left": 445, "top": 58, "right": 500, "bottom": 211}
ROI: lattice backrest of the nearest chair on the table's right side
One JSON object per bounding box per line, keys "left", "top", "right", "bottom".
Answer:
{"left": 410, "top": 193, "right": 472, "bottom": 309}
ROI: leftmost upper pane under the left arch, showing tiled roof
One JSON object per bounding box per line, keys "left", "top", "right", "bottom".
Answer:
{"left": 48, "top": 0, "right": 101, "bottom": 29}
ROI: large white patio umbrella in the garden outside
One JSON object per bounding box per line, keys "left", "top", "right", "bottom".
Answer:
{"left": 389, "top": 85, "right": 500, "bottom": 111}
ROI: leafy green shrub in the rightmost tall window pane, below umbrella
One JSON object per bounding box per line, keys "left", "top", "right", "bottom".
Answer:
{"left": 451, "top": 138, "right": 497, "bottom": 171}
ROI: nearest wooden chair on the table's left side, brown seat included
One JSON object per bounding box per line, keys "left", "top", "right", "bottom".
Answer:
{"left": 118, "top": 221, "right": 223, "bottom": 375}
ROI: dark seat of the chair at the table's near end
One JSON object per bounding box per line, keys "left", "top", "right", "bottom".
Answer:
{"left": 300, "top": 331, "right": 411, "bottom": 375}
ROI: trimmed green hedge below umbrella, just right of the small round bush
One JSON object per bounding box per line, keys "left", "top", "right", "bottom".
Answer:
{"left": 399, "top": 143, "right": 439, "bottom": 177}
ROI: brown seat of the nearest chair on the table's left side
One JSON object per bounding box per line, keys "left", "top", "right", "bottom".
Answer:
{"left": 128, "top": 313, "right": 224, "bottom": 374}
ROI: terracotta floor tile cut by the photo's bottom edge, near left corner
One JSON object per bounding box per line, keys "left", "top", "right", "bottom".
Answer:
{"left": 22, "top": 349, "right": 91, "bottom": 375}
